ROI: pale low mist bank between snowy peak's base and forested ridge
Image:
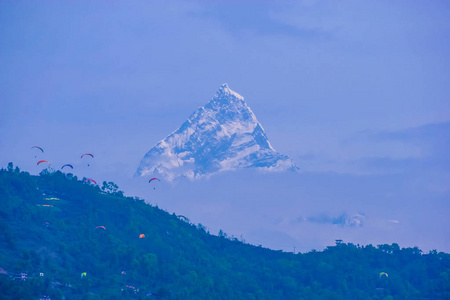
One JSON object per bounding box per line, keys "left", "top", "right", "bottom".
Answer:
{"left": 115, "top": 170, "right": 450, "bottom": 252}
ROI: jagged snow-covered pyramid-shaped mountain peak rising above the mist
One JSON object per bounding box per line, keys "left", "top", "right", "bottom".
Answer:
{"left": 136, "top": 84, "right": 298, "bottom": 180}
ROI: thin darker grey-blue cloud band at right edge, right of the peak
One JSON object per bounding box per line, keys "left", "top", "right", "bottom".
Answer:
{"left": 342, "top": 122, "right": 450, "bottom": 173}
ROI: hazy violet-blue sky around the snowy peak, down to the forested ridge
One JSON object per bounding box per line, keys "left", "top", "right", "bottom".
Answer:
{"left": 0, "top": 0, "right": 450, "bottom": 252}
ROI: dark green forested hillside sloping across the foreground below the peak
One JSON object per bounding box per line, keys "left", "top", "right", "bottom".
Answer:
{"left": 0, "top": 164, "right": 450, "bottom": 299}
